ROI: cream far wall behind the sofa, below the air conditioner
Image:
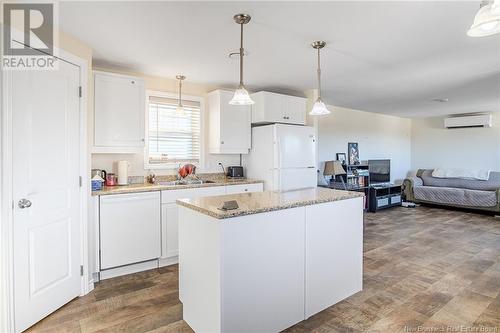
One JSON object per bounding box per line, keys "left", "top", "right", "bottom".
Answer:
{"left": 411, "top": 113, "right": 500, "bottom": 171}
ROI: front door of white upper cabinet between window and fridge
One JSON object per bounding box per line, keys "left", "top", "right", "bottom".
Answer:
{"left": 220, "top": 91, "right": 251, "bottom": 154}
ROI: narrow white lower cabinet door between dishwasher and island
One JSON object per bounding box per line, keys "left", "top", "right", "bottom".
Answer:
{"left": 161, "top": 203, "right": 179, "bottom": 258}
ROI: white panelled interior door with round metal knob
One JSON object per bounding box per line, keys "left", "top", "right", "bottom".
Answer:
{"left": 10, "top": 55, "right": 81, "bottom": 332}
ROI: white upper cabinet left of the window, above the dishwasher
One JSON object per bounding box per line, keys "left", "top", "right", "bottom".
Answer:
{"left": 92, "top": 72, "right": 146, "bottom": 153}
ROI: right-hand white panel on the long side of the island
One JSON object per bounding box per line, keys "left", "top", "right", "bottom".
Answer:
{"left": 305, "top": 198, "right": 363, "bottom": 318}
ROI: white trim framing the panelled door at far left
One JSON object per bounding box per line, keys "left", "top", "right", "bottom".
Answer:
{"left": 0, "top": 49, "right": 91, "bottom": 332}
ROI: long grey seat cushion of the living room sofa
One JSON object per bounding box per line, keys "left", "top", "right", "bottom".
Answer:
{"left": 413, "top": 186, "right": 497, "bottom": 207}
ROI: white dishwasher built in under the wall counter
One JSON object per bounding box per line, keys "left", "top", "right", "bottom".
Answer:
{"left": 99, "top": 192, "right": 161, "bottom": 270}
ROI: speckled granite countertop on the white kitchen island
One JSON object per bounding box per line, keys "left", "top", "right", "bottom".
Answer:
{"left": 177, "top": 187, "right": 364, "bottom": 219}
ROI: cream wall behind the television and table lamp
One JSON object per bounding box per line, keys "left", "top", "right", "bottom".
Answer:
{"left": 317, "top": 106, "right": 411, "bottom": 182}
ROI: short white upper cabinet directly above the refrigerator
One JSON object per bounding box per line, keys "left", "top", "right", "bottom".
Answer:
{"left": 252, "top": 91, "right": 307, "bottom": 125}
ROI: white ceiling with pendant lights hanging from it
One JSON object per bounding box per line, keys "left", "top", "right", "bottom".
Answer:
{"left": 59, "top": 1, "right": 500, "bottom": 117}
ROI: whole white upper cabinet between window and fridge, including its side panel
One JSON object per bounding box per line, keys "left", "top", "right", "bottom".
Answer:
{"left": 208, "top": 90, "right": 252, "bottom": 154}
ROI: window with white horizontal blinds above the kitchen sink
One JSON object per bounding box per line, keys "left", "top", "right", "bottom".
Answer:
{"left": 145, "top": 93, "right": 201, "bottom": 168}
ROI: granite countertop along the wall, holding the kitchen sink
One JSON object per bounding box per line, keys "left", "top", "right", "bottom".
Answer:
{"left": 92, "top": 178, "right": 262, "bottom": 195}
